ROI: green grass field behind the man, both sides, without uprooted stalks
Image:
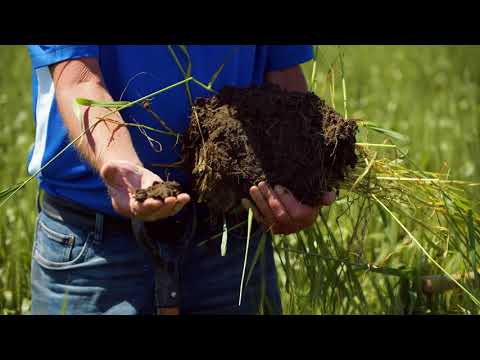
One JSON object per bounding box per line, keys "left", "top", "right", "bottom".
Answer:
{"left": 0, "top": 46, "right": 480, "bottom": 314}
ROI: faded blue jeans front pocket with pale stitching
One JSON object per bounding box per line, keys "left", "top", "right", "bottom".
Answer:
{"left": 32, "top": 212, "right": 94, "bottom": 270}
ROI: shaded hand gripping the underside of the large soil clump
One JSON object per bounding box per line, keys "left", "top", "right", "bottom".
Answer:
{"left": 242, "top": 181, "right": 335, "bottom": 235}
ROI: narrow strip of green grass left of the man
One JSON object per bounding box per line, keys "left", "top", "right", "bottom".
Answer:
{"left": 0, "top": 46, "right": 36, "bottom": 314}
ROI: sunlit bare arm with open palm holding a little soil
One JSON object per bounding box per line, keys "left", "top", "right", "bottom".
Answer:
{"left": 50, "top": 58, "right": 190, "bottom": 221}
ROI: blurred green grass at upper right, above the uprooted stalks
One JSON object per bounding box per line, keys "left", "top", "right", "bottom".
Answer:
{"left": 306, "top": 46, "right": 480, "bottom": 180}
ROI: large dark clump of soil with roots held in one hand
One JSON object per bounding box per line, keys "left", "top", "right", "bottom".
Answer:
{"left": 183, "top": 84, "right": 357, "bottom": 213}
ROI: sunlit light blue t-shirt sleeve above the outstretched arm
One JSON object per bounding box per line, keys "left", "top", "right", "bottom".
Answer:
{"left": 27, "top": 45, "right": 99, "bottom": 69}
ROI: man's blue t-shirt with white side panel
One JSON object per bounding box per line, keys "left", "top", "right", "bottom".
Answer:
{"left": 28, "top": 45, "right": 313, "bottom": 215}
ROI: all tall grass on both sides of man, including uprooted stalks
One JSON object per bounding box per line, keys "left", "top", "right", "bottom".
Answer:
{"left": 0, "top": 46, "right": 480, "bottom": 314}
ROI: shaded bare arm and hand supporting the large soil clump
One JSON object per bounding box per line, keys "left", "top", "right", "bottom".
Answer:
{"left": 248, "top": 65, "right": 335, "bottom": 234}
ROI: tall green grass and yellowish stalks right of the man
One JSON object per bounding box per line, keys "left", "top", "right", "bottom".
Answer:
{"left": 276, "top": 47, "right": 480, "bottom": 314}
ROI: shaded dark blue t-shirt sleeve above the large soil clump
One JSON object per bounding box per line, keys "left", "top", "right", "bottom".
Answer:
{"left": 266, "top": 45, "right": 313, "bottom": 71}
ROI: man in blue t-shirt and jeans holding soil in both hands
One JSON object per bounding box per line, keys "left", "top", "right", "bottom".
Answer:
{"left": 28, "top": 45, "right": 333, "bottom": 314}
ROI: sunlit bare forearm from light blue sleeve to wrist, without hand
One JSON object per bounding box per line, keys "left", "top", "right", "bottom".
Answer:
{"left": 51, "top": 60, "right": 141, "bottom": 170}
